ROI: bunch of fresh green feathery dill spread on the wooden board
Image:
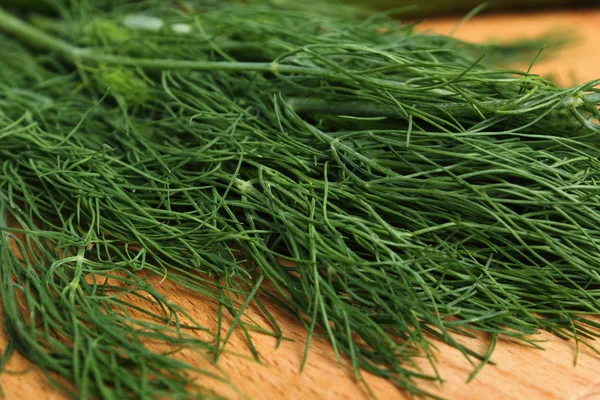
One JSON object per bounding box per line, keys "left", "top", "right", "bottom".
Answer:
{"left": 0, "top": 0, "right": 600, "bottom": 399}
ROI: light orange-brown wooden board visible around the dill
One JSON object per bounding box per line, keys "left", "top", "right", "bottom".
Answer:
{"left": 0, "top": 10, "right": 600, "bottom": 400}
